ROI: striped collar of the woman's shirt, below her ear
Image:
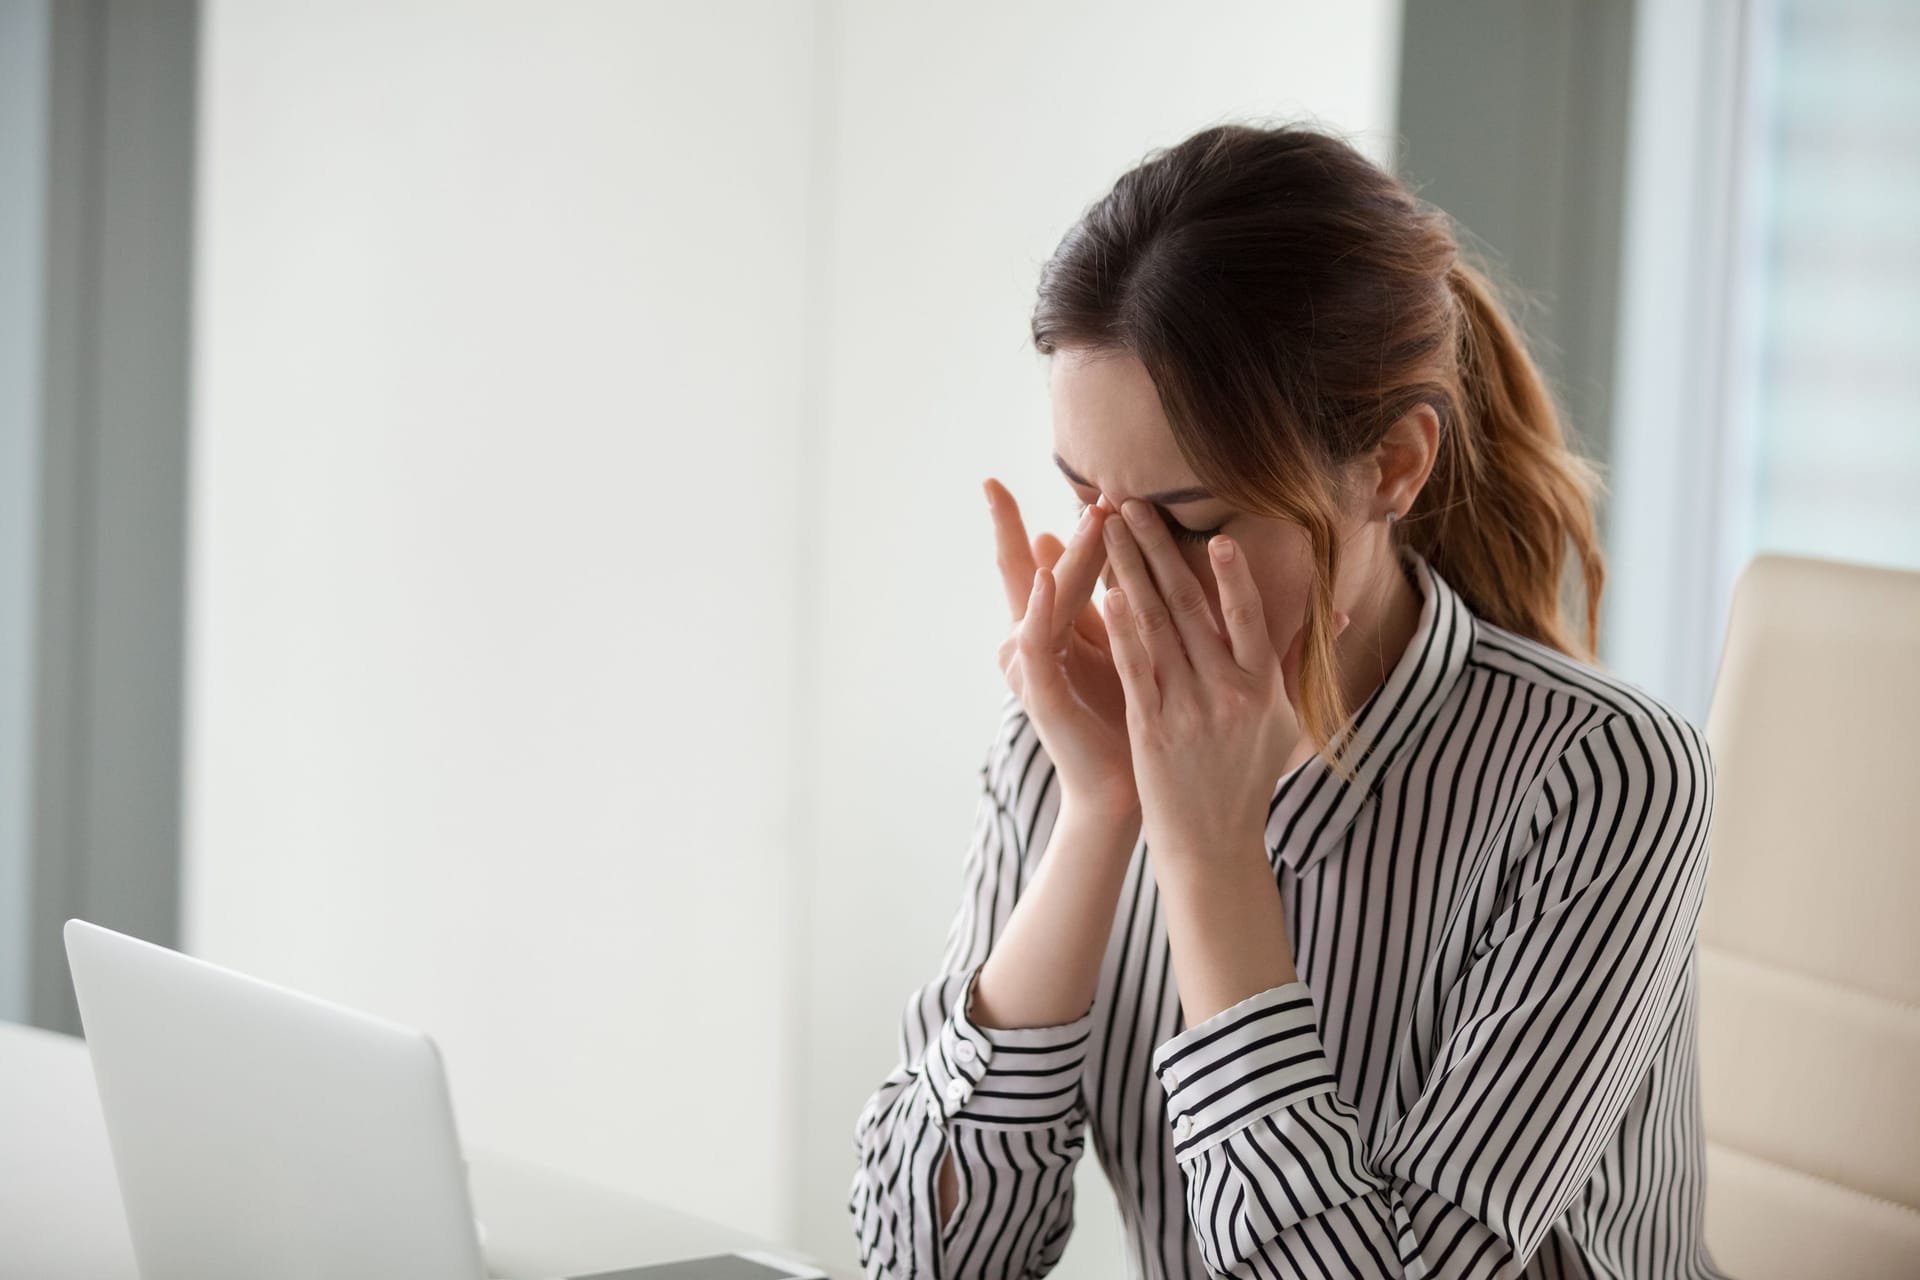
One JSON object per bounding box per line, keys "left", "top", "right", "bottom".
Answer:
{"left": 1267, "top": 547, "right": 1473, "bottom": 871}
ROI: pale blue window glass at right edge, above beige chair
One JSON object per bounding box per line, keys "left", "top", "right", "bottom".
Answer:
{"left": 1749, "top": 0, "right": 1920, "bottom": 566}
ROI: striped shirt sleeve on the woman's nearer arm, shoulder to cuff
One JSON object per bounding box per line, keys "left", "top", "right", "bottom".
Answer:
{"left": 1152, "top": 712, "right": 1713, "bottom": 1280}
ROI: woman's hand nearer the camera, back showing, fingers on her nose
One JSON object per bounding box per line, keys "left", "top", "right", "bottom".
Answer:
{"left": 1104, "top": 499, "right": 1348, "bottom": 860}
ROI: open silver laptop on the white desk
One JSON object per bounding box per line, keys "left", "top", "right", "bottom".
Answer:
{"left": 65, "top": 919, "right": 826, "bottom": 1280}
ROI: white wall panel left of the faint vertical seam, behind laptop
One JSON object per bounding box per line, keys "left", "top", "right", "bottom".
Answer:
{"left": 184, "top": 0, "right": 814, "bottom": 1230}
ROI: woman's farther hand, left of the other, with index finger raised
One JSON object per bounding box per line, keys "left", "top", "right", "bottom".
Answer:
{"left": 983, "top": 480, "right": 1140, "bottom": 814}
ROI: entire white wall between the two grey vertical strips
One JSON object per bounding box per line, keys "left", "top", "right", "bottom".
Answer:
{"left": 186, "top": 0, "right": 1398, "bottom": 1278}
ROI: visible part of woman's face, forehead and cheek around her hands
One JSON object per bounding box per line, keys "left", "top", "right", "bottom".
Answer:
{"left": 1050, "top": 347, "right": 1359, "bottom": 652}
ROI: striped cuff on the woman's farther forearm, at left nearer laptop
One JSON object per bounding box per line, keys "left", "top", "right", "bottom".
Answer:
{"left": 924, "top": 965, "right": 1092, "bottom": 1125}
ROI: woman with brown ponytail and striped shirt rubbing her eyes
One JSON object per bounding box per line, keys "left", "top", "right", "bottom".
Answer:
{"left": 849, "top": 125, "right": 1720, "bottom": 1280}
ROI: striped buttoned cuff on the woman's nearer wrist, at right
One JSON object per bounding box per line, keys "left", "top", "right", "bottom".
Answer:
{"left": 1152, "top": 983, "right": 1336, "bottom": 1159}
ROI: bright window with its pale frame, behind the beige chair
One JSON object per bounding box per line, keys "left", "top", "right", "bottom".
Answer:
{"left": 1601, "top": 0, "right": 1920, "bottom": 723}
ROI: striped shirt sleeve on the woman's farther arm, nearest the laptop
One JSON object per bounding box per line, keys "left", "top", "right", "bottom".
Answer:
{"left": 847, "top": 695, "right": 1092, "bottom": 1280}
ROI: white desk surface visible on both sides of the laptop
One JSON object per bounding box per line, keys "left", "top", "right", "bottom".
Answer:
{"left": 0, "top": 1023, "right": 854, "bottom": 1280}
